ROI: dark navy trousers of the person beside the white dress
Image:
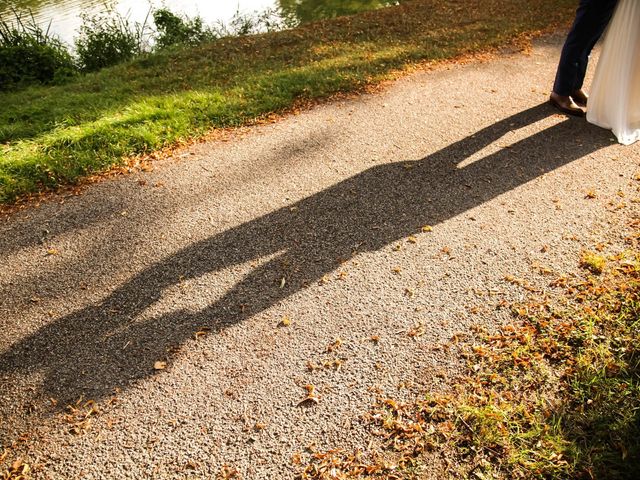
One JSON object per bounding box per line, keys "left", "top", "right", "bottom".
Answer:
{"left": 553, "top": 0, "right": 618, "bottom": 96}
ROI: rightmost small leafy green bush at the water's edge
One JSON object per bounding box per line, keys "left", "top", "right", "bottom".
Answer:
{"left": 153, "top": 8, "right": 217, "bottom": 49}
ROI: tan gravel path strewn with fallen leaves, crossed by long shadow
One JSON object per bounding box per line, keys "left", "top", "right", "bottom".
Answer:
{"left": 0, "top": 35, "right": 640, "bottom": 479}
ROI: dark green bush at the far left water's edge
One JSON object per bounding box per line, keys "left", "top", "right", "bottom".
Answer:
{"left": 0, "top": 15, "right": 77, "bottom": 90}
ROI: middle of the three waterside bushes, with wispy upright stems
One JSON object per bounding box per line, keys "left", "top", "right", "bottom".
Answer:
{"left": 75, "top": 10, "right": 146, "bottom": 72}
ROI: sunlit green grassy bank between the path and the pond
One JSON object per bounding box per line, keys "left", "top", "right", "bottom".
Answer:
{"left": 0, "top": 0, "right": 576, "bottom": 203}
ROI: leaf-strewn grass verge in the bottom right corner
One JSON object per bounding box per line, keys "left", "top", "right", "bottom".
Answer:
{"left": 299, "top": 218, "right": 640, "bottom": 480}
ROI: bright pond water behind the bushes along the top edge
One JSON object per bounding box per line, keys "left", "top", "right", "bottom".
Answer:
{"left": 0, "top": 0, "right": 398, "bottom": 44}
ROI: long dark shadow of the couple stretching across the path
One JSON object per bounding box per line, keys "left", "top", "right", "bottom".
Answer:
{"left": 0, "top": 105, "right": 609, "bottom": 424}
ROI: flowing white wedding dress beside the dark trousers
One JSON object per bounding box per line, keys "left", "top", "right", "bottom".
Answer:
{"left": 587, "top": 0, "right": 640, "bottom": 145}
